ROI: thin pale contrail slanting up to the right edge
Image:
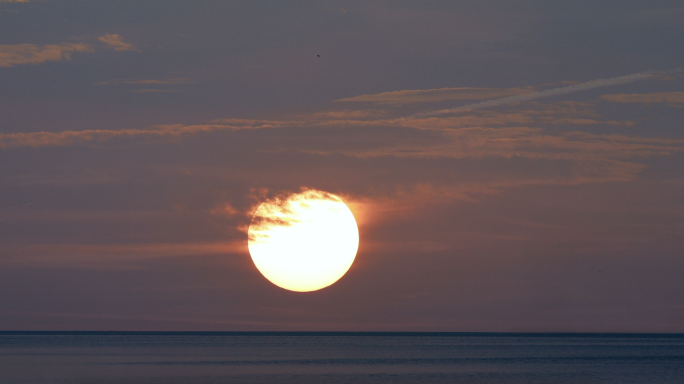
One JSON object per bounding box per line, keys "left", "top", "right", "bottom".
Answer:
{"left": 414, "top": 67, "right": 684, "bottom": 117}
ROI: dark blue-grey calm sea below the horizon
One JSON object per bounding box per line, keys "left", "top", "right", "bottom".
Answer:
{"left": 0, "top": 332, "right": 684, "bottom": 384}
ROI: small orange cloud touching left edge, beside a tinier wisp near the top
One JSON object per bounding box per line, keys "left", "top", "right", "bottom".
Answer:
{"left": 0, "top": 43, "right": 94, "bottom": 67}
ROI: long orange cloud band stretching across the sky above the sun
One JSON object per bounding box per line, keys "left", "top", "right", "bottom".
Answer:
{"left": 0, "top": 103, "right": 664, "bottom": 164}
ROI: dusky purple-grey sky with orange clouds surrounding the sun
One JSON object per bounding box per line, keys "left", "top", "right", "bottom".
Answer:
{"left": 0, "top": 0, "right": 684, "bottom": 332}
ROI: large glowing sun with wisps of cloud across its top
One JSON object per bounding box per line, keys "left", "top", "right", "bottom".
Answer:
{"left": 248, "top": 189, "right": 359, "bottom": 292}
